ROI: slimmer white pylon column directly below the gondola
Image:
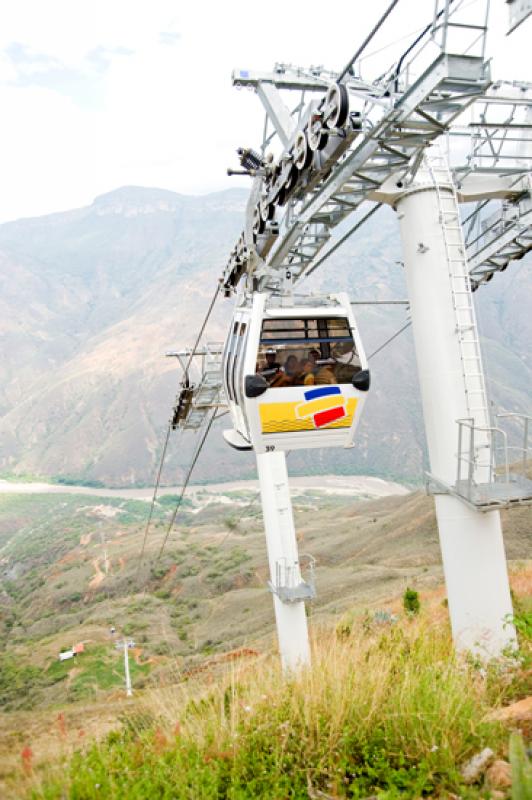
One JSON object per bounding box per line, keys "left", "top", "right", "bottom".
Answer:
{"left": 257, "top": 451, "right": 310, "bottom": 671}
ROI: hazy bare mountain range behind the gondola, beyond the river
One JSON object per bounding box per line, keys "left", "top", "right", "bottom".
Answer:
{"left": 0, "top": 187, "right": 532, "bottom": 485}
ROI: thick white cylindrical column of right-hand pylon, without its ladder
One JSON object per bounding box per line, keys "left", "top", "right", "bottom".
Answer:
{"left": 395, "top": 172, "right": 516, "bottom": 658}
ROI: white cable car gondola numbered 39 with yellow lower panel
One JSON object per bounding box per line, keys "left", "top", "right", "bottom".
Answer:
{"left": 222, "top": 292, "right": 370, "bottom": 453}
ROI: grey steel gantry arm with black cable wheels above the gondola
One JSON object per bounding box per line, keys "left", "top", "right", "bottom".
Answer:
{"left": 222, "top": 1, "right": 490, "bottom": 292}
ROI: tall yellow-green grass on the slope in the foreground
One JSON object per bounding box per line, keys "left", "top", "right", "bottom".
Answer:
{"left": 21, "top": 614, "right": 530, "bottom": 800}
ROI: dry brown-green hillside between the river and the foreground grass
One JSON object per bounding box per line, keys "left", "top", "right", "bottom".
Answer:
{"left": 0, "top": 487, "right": 532, "bottom": 712}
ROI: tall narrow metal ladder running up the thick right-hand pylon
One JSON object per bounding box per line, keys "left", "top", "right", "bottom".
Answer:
{"left": 426, "top": 153, "right": 493, "bottom": 481}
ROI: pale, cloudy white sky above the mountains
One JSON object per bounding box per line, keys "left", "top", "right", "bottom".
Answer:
{"left": 0, "top": 0, "right": 532, "bottom": 222}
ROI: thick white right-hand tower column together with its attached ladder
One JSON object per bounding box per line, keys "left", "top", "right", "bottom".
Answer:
{"left": 395, "top": 159, "right": 516, "bottom": 658}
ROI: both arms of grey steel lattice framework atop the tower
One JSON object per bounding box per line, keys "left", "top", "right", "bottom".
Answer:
{"left": 222, "top": 0, "right": 532, "bottom": 294}
